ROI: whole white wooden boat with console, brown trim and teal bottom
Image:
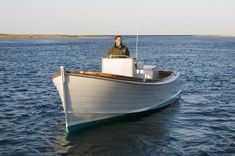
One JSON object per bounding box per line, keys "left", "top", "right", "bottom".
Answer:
{"left": 52, "top": 58, "right": 181, "bottom": 133}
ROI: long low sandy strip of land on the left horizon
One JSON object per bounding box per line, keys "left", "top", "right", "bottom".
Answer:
{"left": 0, "top": 34, "right": 107, "bottom": 38}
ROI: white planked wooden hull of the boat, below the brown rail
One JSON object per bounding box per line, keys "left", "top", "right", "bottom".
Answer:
{"left": 53, "top": 70, "right": 180, "bottom": 132}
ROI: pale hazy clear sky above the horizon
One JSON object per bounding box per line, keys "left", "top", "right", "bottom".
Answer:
{"left": 0, "top": 0, "right": 235, "bottom": 35}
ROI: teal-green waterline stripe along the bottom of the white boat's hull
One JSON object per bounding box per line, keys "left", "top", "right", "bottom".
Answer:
{"left": 66, "top": 92, "right": 180, "bottom": 134}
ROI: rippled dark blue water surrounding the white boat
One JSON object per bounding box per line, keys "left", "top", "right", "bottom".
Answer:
{"left": 0, "top": 36, "right": 235, "bottom": 156}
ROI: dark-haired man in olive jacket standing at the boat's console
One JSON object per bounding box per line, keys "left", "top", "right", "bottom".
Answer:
{"left": 108, "top": 36, "right": 130, "bottom": 58}
